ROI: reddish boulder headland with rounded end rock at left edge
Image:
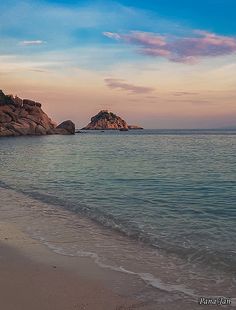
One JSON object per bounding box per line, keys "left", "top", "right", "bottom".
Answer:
{"left": 0, "top": 90, "right": 75, "bottom": 137}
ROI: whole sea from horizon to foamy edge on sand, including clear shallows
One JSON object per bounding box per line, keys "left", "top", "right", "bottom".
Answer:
{"left": 0, "top": 130, "right": 236, "bottom": 309}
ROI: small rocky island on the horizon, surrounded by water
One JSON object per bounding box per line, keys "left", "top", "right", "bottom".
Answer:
{"left": 82, "top": 110, "right": 143, "bottom": 131}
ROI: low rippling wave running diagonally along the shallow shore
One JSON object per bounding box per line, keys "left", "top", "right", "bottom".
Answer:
{"left": 0, "top": 181, "right": 236, "bottom": 272}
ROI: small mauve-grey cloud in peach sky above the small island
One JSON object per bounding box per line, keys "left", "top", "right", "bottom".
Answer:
{"left": 104, "top": 78, "right": 154, "bottom": 94}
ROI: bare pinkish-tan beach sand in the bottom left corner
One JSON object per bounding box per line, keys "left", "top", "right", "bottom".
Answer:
{"left": 0, "top": 222, "right": 155, "bottom": 310}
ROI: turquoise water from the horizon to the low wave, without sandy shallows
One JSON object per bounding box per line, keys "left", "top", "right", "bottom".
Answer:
{"left": 0, "top": 130, "right": 236, "bottom": 300}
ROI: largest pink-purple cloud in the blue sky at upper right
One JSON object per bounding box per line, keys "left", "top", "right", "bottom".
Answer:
{"left": 103, "top": 30, "right": 236, "bottom": 64}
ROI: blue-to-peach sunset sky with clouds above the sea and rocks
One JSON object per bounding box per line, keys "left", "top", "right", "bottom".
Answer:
{"left": 0, "top": 0, "right": 236, "bottom": 128}
